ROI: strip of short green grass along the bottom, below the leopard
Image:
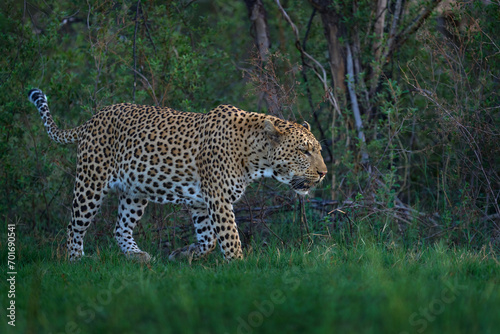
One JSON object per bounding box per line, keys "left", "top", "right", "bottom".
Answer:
{"left": 0, "top": 232, "right": 500, "bottom": 333}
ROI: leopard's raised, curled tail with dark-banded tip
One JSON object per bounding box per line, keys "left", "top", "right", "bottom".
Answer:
{"left": 28, "top": 88, "right": 78, "bottom": 144}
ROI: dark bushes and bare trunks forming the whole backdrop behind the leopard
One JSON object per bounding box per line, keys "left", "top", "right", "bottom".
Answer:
{"left": 0, "top": 0, "right": 500, "bottom": 254}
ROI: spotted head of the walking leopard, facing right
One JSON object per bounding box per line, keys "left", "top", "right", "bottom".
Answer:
{"left": 264, "top": 118, "right": 327, "bottom": 195}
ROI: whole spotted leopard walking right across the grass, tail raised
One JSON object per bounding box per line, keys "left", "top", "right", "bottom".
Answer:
{"left": 28, "top": 88, "right": 327, "bottom": 263}
